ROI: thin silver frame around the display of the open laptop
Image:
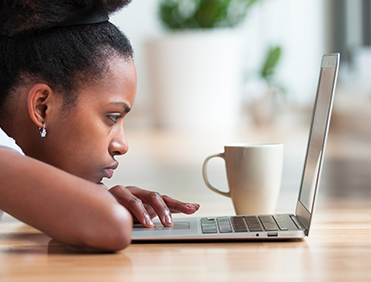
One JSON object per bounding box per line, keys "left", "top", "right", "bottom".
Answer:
{"left": 295, "top": 53, "right": 340, "bottom": 235}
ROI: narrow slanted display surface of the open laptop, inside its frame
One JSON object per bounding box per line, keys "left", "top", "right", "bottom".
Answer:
{"left": 299, "top": 57, "right": 336, "bottom": 213}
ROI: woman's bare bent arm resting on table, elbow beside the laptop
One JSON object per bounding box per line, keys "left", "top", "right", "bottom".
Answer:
{"left": 0, "top": 148, "right": 132, "bottom": 251}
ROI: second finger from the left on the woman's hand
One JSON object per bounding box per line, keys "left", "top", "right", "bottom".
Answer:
{"left": 127, "top": 186, "right": 173, "bottom": 226}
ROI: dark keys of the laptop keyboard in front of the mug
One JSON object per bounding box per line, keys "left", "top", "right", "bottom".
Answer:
{"left": 201, "top": 215, "right": 288, "bottom": 234}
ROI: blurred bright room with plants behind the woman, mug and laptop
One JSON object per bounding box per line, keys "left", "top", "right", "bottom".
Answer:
{"left": 99, "top": 0, "right": 371, "bottom": 213}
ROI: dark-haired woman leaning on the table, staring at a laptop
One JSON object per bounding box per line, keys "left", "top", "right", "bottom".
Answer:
{"left": 0, "top": 0, "right": 199, "bottom": 251}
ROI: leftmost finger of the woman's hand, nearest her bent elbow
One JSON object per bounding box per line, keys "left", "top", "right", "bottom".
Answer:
{"left": 109, "top": 186, "right": 154, "bottom": 227}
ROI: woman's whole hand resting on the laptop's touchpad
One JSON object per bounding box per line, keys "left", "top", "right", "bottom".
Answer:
{"left": 109, "top": 185, "right": 200, "bottom": 227}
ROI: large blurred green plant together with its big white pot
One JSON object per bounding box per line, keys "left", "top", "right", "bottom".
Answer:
{"left": 146, "top": 0, "right": 259, "bottom": 132}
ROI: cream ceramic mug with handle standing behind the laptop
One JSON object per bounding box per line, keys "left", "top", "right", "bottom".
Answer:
{"left": 202, "top": 144, "right": 283, "bottom": 215}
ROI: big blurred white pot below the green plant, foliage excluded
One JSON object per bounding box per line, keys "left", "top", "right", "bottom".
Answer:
{"left": 146, "top": 30, "right": 246, "bottom": 132}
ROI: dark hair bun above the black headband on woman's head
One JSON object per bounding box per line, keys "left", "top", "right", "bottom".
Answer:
{"left": 0, "top": 0, "right": 131, "bottom": 36}
